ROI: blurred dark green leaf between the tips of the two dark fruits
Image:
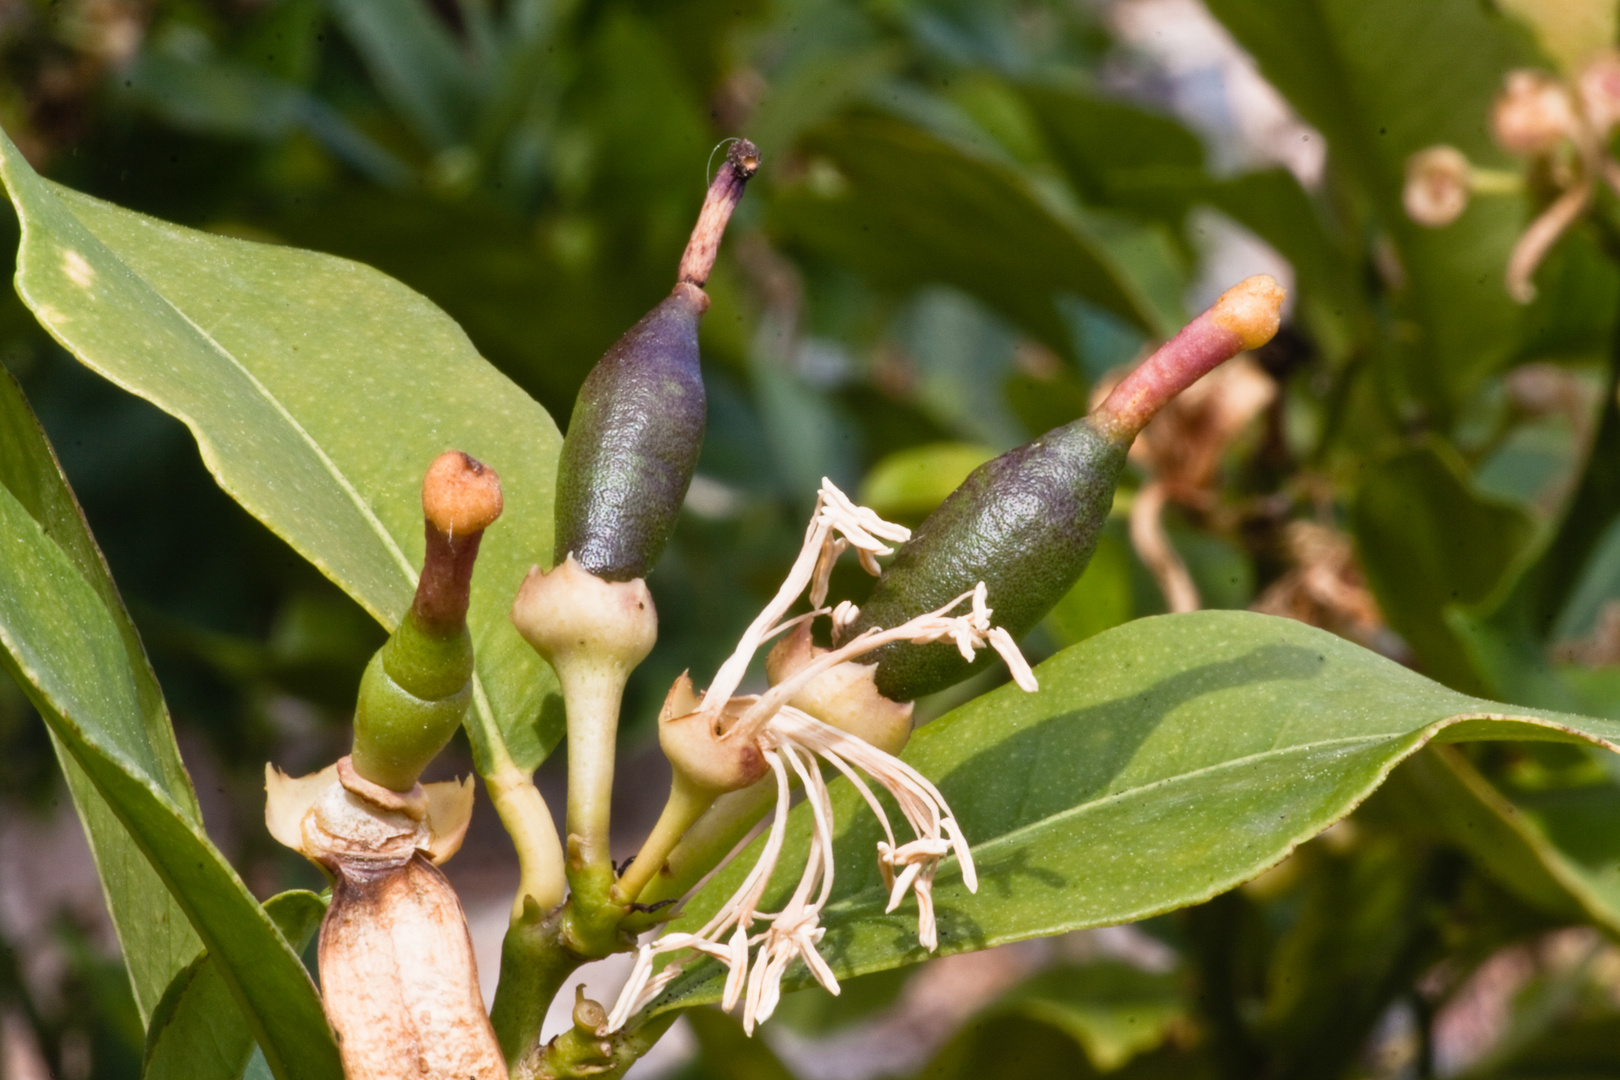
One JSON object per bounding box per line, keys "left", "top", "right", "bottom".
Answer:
{"left": 771, "top": 117, "right": 1163, "bottom": 353}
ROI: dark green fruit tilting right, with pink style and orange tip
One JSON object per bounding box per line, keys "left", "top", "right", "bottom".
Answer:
{"left": 838, "top": 274, "right": 1283, "bottom": 701}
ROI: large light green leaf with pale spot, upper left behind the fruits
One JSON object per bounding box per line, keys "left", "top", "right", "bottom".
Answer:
{"left": 0, "top": 122, "right": 562, "bottom": 776}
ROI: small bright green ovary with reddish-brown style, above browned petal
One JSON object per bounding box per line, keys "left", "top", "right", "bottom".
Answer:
{"left": 353, "top": 450, "right": 502, "bottom": 792}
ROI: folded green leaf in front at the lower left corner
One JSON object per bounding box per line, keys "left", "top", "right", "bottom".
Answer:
{"left": 0, "top": 453, "right": 342, "bottom": 1080}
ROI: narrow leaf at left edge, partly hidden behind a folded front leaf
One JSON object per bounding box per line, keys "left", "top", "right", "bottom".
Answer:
{"left": 0, "top": 362, "right": 203, "bottom": 1023}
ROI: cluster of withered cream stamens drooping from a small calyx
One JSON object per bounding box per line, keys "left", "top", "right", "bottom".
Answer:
{"left": 609, "top": 479, "right": 1035, "bottom": 1033}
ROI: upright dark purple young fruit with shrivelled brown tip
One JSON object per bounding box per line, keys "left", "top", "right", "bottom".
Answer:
{"left": 556, "top": 139, "right": 760, "bottom": 581}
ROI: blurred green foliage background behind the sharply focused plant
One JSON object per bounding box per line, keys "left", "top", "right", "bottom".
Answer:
{"left": 9, "top": 0, "right": 1620, "bottom": 1080}
